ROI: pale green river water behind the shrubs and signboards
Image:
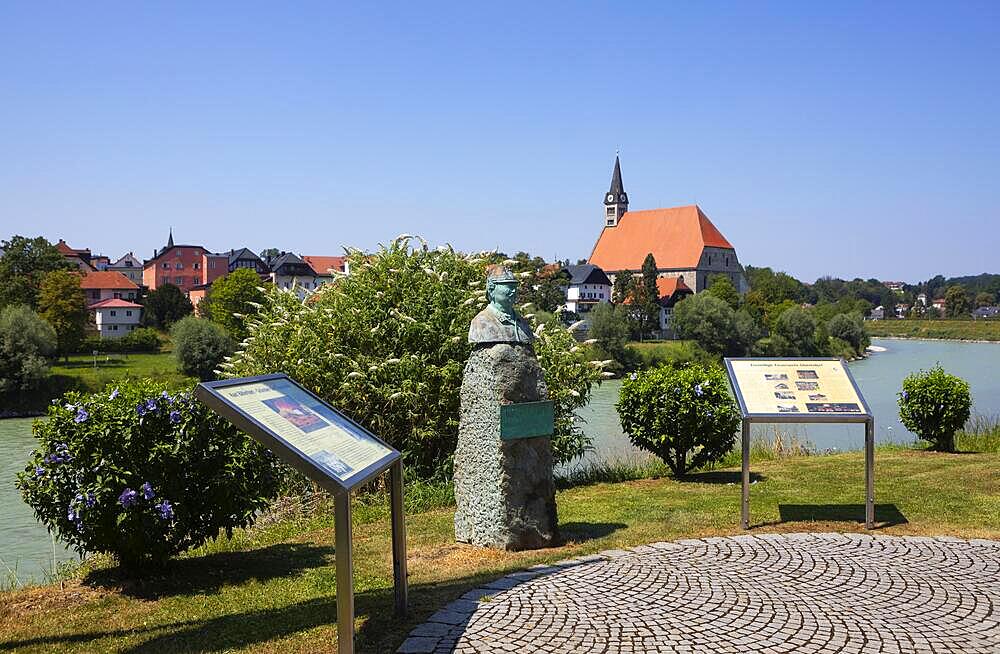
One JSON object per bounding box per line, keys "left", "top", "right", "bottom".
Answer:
{"left": 0, "top": 339, "right": 1000, "bottom": 587}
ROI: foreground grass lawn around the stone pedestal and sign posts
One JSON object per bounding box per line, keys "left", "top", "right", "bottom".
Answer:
{"left": 0, "top": 447, "right": 1000, "bottom": 652}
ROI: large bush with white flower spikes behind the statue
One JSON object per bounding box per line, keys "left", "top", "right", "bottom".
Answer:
{"left": 222, "top": 236, "right": 601, "bottom": 479}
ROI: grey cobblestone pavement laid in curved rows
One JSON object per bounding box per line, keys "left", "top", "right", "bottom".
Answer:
{"left": 398, "top": 534, "right": 1000, "bottom": 654}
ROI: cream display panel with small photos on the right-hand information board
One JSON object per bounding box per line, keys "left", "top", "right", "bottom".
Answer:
{"left": 726, "top": 358, "right": 870, "bottom": 417}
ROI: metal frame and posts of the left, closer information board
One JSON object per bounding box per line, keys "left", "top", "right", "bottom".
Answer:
{"left": 195, "top": 373, "right": 407, "bottom": 654}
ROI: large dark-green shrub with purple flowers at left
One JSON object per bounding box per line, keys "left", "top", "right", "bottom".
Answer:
{"left": 17, "top": 381, "right": 279, "bottom": 568}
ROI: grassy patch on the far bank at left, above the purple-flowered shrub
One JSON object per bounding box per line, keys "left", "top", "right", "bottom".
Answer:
{"left": 4, "top": 352, "right": 196, "bottom": 413}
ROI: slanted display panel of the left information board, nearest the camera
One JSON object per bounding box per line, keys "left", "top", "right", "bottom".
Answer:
{"left": 200, "top": 375, "right": 398, "bottom": 486}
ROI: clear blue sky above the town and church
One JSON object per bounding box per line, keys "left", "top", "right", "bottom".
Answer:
{"left": 0, "top": 2, "right": 1000, "bottom": 281}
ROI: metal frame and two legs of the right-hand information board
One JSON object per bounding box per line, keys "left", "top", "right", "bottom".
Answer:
{"left": 724, "top": 357, "right": 875, "bottom": 529}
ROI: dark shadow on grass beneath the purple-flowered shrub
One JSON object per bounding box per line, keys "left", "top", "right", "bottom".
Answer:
{"left": 83, "top": 543, "right": 334, "bottom": 600}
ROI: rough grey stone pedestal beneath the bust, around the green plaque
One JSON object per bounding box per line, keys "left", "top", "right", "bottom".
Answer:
{"left": 455, "top": 343, "right": 558, "bottom": 550}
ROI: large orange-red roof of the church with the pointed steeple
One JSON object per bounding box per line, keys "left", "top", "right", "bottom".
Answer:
{"left": 590, "top": 204, "right": 734, "bottom": 271}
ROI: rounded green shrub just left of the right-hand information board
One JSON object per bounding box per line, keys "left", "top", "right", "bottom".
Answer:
{"left": 617, "top": 364, "right": 740, "bottom": 475}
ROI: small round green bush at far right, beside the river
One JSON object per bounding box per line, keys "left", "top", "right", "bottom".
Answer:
{"left": 899, "top": 366, "right": 972, "bottom": 452}
